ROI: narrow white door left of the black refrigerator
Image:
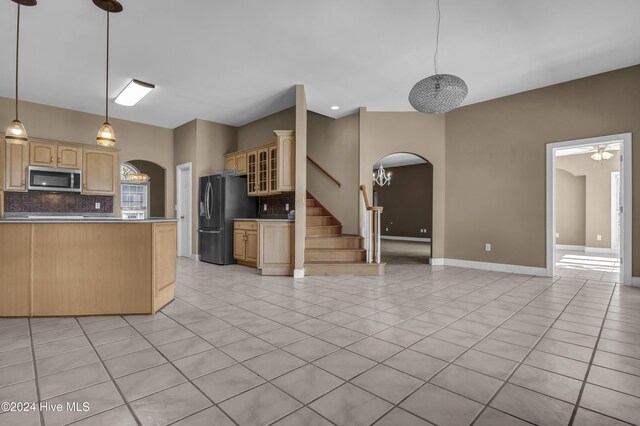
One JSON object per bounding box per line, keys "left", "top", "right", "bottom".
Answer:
{"left": 176, "top": 163, "right": 193, "bottom": 258}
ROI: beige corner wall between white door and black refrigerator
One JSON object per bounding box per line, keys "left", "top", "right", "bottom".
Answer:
{"left": 174, "top": 119, "right": 237, "bottom": 254}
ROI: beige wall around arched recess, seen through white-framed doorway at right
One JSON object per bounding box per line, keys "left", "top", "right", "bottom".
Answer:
{"left": 556, "top": 151, "right": 620, "bottom": 248}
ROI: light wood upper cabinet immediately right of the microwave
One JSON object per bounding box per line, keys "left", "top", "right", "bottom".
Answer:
{"left": 82, "top": 149, "right": 119, "bottom": 195}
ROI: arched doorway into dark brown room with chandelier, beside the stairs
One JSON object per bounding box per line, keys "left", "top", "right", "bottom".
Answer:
{"left": 373, "top": 152, "right": 433, "bottom": 264}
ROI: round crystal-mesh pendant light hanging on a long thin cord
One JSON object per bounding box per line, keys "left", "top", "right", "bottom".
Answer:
{"left": 409, "top": 0, "right": 469, "bottom": 114}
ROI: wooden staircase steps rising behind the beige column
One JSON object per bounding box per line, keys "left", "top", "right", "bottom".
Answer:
{"left": 304, "top": 193, "right": 385, "bottom": 276}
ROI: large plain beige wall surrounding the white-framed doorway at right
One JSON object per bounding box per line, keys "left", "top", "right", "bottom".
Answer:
{"left": 446, "top": 66, "right": 640, "bottom": 276}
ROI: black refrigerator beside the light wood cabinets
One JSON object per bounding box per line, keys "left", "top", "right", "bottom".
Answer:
{"left": 198, "top": 175, "right": 258, "bottom": 265}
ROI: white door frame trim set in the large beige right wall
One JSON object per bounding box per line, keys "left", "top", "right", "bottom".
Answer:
{"left": 546, "top": 133, "right": 633, "bottom": 285}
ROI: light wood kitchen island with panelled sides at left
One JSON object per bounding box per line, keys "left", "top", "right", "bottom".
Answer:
{"left": 0, "top": 217, "right": 176, "bottom": 317}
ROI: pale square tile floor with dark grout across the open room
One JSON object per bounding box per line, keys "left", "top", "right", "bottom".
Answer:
{"left": 0, "top": 259, "right": 640, "bottom": 426}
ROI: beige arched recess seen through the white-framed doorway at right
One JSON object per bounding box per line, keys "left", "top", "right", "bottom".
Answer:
{"left": 555, "top": 168, "right": 593, "bottom": 246}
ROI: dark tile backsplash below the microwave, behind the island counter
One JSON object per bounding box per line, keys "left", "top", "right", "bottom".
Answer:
{"left": 4, "top": 192, "right": 113, "bottom": 213}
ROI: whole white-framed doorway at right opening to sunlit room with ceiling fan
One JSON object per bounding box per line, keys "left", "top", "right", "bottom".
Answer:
{"left": 547, "top": 134, "right": 631, "bottom": 283}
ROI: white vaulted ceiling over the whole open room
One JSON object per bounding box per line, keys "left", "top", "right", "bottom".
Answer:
{"left": 0, "top": 0, "right": 640, "bottom": 128}
